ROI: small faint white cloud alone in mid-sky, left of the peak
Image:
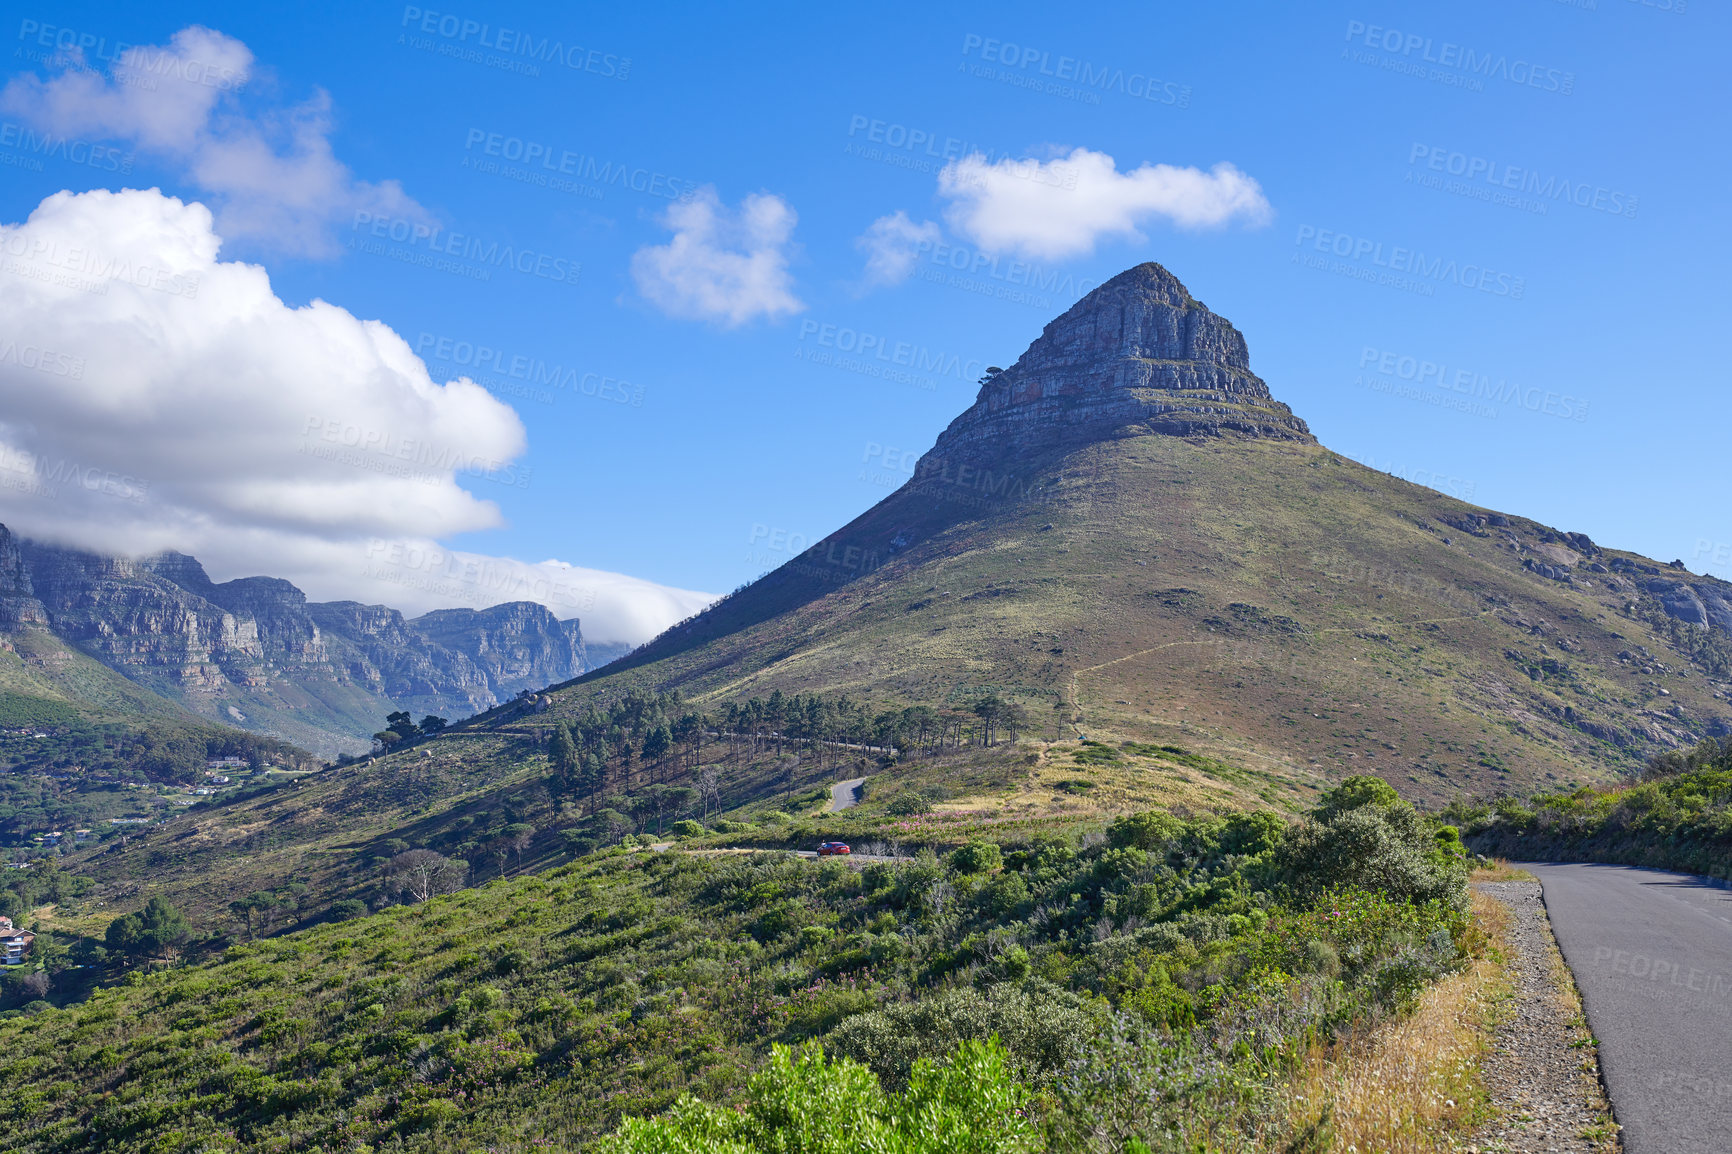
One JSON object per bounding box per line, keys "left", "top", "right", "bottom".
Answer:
{"left": 632, "top": 187, "right": 805, "bottom": 327}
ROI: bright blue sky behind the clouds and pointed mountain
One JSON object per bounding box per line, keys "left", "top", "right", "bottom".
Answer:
{"left": 0, "top": 0, "right": 1732, "bottom": 639}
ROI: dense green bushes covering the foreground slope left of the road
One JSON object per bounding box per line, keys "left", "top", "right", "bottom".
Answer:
{"left": 0, "top": 772, "right": 1467, "bottom": 1154}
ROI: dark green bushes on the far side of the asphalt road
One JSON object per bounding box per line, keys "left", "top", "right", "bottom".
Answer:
{"left": 1448, "top": 738, "right": 1732, "bottom": 878}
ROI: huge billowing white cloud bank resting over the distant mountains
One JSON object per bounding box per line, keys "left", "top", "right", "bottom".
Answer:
{"left": 0, "top": 191, "right": 708, "bottom": 641}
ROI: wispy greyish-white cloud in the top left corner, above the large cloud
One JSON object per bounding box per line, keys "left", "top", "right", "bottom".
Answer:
{"left": 0, "top": 26, "right": 426, "bottom": 256}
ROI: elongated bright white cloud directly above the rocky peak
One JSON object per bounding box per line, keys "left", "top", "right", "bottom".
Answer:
{"left": 939, "top": 149, "right": 1271, "bottom": 260}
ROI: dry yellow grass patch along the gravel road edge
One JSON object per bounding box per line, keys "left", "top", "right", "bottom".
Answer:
{"left": 1290, "top": 892, "right": 1509, "bottom": 1154}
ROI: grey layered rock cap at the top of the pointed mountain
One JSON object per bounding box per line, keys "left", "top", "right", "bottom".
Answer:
{"left": 916, "top": 263, "right": 1315, "bottom": 477}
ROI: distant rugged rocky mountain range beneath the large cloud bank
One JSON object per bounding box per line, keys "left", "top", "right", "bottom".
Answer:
{"left": 0, "top": 525, "right": 630, "bottom": 755}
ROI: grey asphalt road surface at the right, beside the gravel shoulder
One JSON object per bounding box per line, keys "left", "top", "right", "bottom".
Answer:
{"left": 1522, "top": 863, "right": 1732, "bottom": 1154}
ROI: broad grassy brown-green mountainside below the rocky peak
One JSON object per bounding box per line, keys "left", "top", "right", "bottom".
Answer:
{"left": 556, "top": 435, "right": 1732, "bottom": 801}
